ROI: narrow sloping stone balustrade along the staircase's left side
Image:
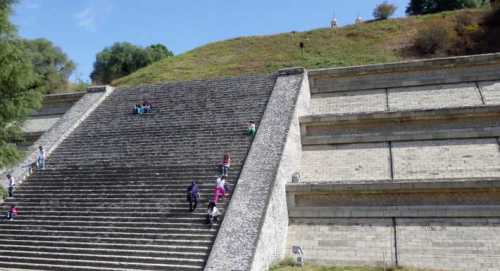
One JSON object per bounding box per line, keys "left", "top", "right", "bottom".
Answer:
{"left": 0, "top": 86, "right": 113, "bottom": 190}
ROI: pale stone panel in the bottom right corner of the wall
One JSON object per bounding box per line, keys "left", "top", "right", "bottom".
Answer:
{"left": 396, "top": 218, "right": 500, "bottom": 271}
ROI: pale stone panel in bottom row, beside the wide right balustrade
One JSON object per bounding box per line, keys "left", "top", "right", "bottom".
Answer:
{"left": 288, "top": 218, "right": 394, "bottom": 266}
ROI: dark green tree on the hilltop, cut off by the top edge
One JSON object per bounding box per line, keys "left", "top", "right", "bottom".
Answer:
{"left": 406, "top": 0, "right": 482, "bottom": 15}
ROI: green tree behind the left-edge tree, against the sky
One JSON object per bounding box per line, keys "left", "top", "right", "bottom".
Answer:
{"left": 23, "top": 39, "right": 75, "bottom": 93}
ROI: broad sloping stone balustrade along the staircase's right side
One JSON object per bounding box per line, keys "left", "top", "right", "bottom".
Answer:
{"left": 205, "top": 69, "right": 309, "bottom": 271}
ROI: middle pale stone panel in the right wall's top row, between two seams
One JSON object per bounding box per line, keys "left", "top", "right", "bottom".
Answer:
{"left": 389, "top": 84, "right": 482, "bottom": 111}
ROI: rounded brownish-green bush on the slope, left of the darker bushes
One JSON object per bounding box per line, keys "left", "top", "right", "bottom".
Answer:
{"left": 413, "top": 26, "right": 453, "bottom": 55}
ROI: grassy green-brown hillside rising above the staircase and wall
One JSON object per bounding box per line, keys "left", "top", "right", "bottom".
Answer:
{"left": 113, "top": 10, "right": 485, "bottom": 85}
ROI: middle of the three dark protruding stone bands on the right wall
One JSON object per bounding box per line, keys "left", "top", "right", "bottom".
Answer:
{"left": 301, "top": 105, "right": 500, "bottom": 145}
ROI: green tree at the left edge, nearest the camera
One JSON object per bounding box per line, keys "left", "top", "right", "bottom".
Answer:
{"left": 0, "top": 0, "right": 41, "bottom": 168}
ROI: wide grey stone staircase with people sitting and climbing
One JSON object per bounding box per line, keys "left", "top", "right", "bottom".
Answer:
{"left": 0, "top": 76, "right": 275, "bottom": 271}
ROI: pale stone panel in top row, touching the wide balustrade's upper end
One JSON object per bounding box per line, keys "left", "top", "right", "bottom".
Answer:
{"left": 311, "top": 89, "right": 387, "bottom": 115}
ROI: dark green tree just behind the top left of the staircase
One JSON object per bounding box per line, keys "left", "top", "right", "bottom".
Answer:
{"left": 90, "top": 42, "right": 173, "bottom": 84}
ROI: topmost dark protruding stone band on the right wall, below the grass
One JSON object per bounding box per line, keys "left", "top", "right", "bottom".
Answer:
{"left": 309, "top": 53, "right": 500, "bottom": 94}
